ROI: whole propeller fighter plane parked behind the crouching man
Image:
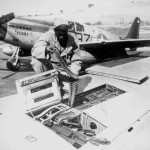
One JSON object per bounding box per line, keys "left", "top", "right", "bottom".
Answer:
{"left": 0, "top": 13, "right": 150, "bottom": 71}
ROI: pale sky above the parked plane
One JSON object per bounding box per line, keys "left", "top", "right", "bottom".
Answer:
{"left": 0, "top": 0, "right": 150, "bottom": 21}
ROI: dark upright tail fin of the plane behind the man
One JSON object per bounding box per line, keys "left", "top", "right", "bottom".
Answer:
{"left": 126, "top": 17, "right": 141, "bottom": 39}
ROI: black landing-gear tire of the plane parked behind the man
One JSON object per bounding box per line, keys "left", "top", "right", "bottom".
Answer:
{"left": 6, "top": 57, "right": 20, "bottom": 71}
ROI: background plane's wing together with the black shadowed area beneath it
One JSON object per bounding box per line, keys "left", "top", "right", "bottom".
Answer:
{"left": 79, "top": 39, "right": 150, "bottom": 60}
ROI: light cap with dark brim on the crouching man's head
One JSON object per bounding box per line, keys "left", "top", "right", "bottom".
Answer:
{"left": 54, "top": 19, "right": 69, "bottom": 32}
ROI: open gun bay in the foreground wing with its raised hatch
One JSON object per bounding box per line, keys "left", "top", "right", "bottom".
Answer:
{"left": 16, "top": 70, "right": 125, "bottom": 148}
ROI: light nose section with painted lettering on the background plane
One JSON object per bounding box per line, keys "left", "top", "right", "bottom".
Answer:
{"left": 3, "top": 18, "right": 53, "bottom": 49}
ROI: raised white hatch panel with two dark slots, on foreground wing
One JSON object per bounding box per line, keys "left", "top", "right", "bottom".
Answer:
{"left": 16, "top": 70, "right": 62, "bottom": 112}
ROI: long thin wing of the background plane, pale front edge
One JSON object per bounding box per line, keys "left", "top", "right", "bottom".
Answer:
{"left": 79, "top": 39, "right": 150, "bottom": 50}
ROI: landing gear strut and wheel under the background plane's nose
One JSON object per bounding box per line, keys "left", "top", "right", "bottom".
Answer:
{"left": 6, "top": 47, "right": 20, "bottom": 71}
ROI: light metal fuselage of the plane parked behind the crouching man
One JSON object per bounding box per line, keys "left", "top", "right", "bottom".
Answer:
{"left": 0, "top": 17, "right": 119, "bottom": 50}
